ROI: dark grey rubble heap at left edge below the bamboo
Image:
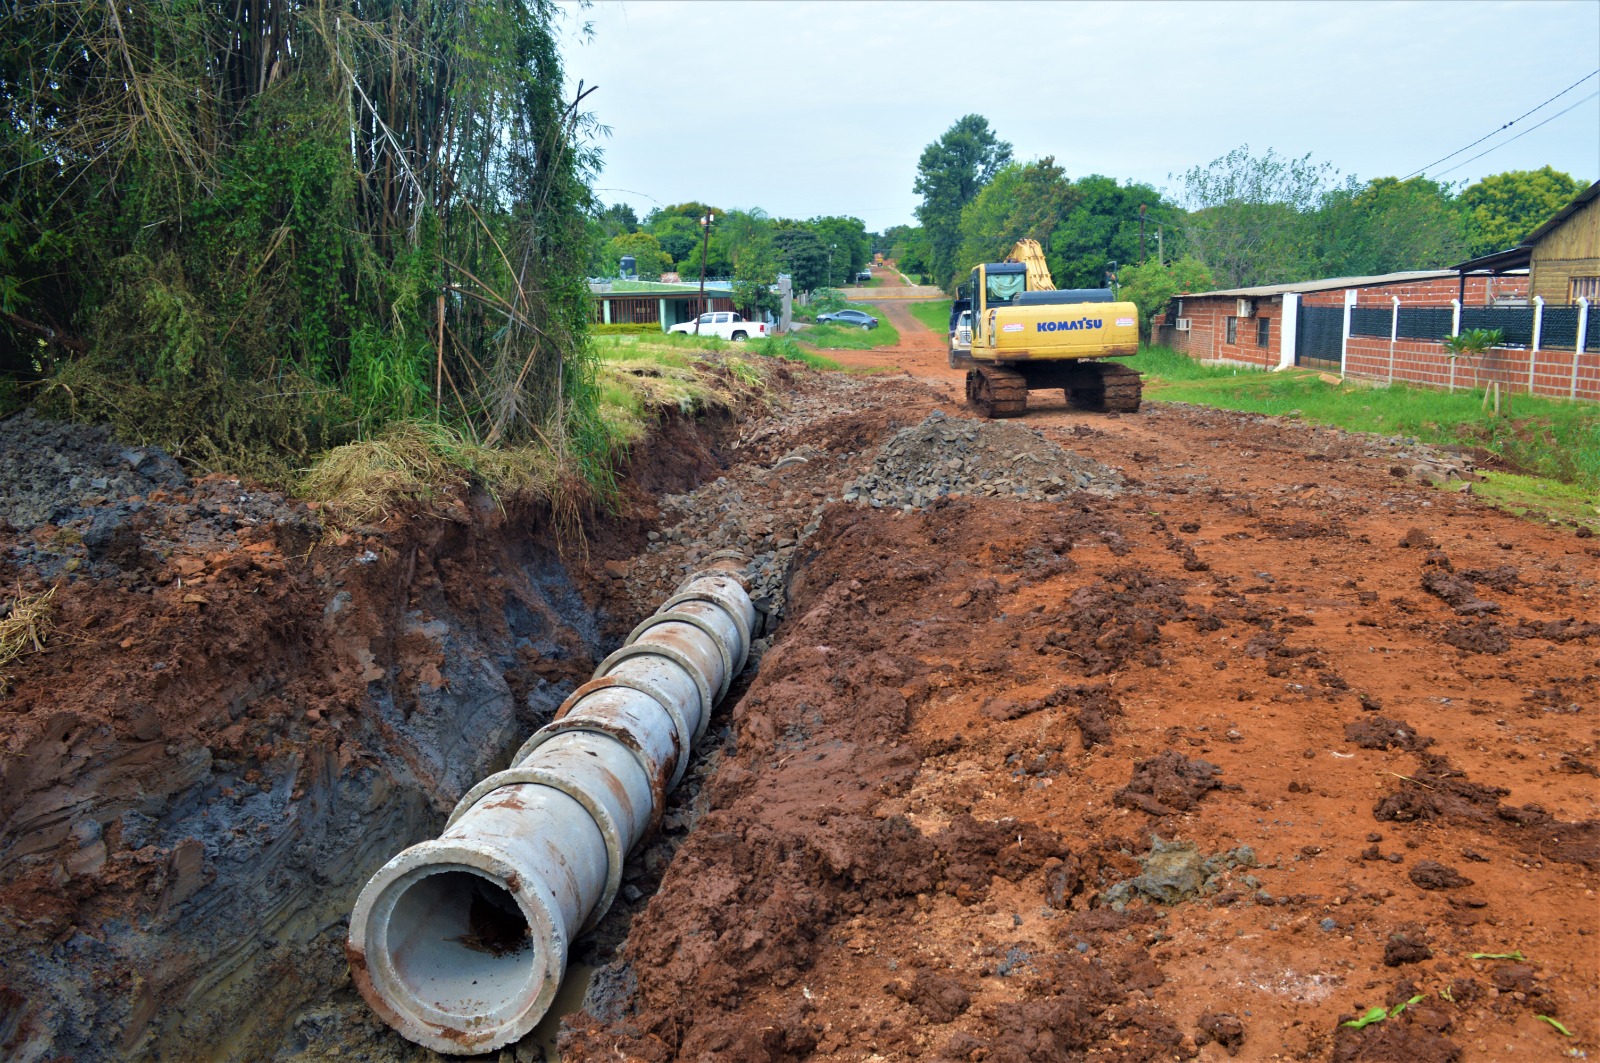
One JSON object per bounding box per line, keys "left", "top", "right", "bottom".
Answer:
{"left": 0, "top": 410, "right": 189, "bottom": 528}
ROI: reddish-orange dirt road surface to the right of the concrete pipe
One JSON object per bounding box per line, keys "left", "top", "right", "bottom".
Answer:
{"left": 565, "top": 332, "right": 1600, "bottom": 1063}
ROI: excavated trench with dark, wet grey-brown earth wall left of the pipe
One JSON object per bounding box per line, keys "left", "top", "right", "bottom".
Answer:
{"left": 0, "top": 400, "right": 768, "bottom": 1061}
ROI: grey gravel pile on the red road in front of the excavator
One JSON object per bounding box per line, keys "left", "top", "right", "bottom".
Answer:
{"left": 843, "top": 410, "right": 1123, "bottom": 511}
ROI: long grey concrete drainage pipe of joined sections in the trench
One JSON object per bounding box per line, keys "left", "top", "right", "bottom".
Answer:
{"left": 346, "top": 569, "right": 755, "bottom": 1055}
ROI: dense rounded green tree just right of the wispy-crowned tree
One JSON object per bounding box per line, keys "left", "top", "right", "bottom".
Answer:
{"left": 1315, "top": 178, "right": 1467, "bottom": 277}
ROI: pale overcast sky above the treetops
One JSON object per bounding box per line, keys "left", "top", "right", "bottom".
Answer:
{"left": 563, "top": 0, "right": 1600, "bottom": 231}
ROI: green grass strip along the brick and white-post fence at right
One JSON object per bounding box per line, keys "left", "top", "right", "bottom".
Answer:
{"left": 1126, "top": 347, "right": 1600, "bottom": 496}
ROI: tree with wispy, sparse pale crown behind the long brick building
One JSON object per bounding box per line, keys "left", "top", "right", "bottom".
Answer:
{"left": 1179, "top": 144, "right": 1338, "bottom": 287}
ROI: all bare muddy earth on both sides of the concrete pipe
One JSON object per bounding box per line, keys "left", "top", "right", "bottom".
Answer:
{"left": 0, "top": 316, "right": 1600, "bottom": 1063}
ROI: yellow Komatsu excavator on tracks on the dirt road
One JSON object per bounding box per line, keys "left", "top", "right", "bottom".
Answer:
{"left": 966, "top": 240, "right": 1141, "bottom": 418}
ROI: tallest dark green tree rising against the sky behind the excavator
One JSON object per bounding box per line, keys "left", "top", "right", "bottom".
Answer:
{"left": 912, "top": 114, "right": 1011, "bottom": 291}
